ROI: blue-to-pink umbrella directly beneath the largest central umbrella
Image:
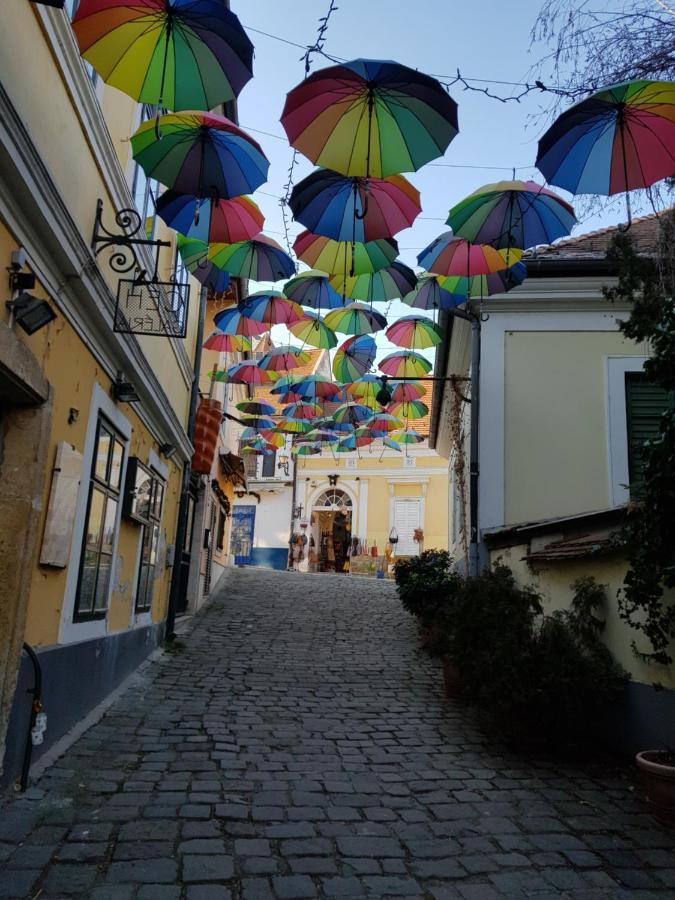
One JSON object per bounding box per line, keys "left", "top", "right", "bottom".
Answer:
{"left": 289, "top": 169, "right": 421, "bottom": 243}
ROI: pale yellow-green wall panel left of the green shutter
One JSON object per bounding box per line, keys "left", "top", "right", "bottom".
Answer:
{"left": 504, "top": 331, "right": 646, "bottom": 525}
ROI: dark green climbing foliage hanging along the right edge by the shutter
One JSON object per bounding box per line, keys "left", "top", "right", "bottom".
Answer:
{"left": 605, "top": 221, "right": 675, "bottom": 665}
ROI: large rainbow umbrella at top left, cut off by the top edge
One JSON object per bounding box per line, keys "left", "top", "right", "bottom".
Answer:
{"left": 73, "top": 0, "right": 253, "bottom": 109}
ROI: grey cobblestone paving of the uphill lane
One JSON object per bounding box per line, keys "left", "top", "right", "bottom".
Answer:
{"left": 0, "top": 570, "right": 675, "bottom": 900}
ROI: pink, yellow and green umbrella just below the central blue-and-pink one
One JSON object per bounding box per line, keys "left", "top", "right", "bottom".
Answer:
{"left": 293, "top": 231, "right": 398, "bottom": 275}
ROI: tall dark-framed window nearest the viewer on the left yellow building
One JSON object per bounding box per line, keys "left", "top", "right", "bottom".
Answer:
{"left": 74, "top": 417, "right": 125, "bottom": 621}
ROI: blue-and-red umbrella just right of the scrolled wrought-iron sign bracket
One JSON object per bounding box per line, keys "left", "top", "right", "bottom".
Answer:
{"left": 156, "top": 191, "right": 265, "bottom": 244}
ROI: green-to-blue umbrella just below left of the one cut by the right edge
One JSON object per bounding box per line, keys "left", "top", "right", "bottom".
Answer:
{"left": 447, "top": 181, "right": 577, "bottom": 249}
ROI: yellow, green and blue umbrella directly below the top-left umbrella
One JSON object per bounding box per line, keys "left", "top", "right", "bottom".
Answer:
{"left": 131, "top": 112, "right": 270, "bottom": 200}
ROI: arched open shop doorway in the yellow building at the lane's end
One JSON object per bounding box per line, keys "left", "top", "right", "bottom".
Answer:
{"left": 309, "top": 488, "right": 352, "bottom": 573}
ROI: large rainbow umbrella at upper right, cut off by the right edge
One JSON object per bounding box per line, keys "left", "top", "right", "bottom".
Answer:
{"left": 536, "top": 80, "right": 675, "bottom": 194}
